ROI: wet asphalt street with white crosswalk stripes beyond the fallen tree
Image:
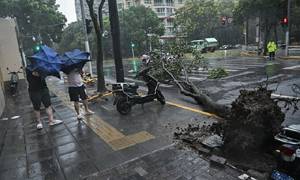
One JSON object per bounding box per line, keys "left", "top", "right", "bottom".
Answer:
{"left": 104, "top": 57, "right": 300, "bottom": 125}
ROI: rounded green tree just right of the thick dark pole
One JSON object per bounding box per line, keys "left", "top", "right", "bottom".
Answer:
{"left": 120, "top": 6, "right": 164, "bottom": 56}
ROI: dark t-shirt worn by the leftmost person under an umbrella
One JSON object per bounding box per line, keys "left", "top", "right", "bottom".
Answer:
{"left": 26, "top": 69, "right": 47, "bottom": 92}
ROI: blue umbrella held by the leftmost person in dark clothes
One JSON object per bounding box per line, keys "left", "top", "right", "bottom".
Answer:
{"left": 28, "top": 45, "right": 62, "bottom": 78}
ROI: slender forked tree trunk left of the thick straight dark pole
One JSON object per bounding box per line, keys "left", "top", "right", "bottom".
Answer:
{"left": 86, "top": 0, "right": 106, "bottom": 92}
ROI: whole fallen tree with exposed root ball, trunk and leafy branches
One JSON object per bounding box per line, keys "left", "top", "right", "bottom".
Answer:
{"left": 150, "top": 49, "right": 299, "bottom": 165}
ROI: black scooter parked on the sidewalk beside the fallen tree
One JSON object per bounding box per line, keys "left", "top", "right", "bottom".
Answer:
{"left": 112, "top": 67, "right": 166, "bottom": 115}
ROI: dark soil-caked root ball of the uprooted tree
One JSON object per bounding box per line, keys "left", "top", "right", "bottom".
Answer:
{"left": 223, "top": 87, "right": 284, "bottom": 158}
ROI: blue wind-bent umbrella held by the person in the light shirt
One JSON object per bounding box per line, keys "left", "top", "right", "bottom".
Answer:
{"left": 60, "top": 49, "right": 90, "bottom": 74}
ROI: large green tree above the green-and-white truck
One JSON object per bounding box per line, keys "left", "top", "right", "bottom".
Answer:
{"left": 175, "top": 0, "right": 242, "bottom": 44}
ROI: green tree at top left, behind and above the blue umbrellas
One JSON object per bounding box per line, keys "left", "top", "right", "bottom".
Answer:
{"left": 0, "top": 0, "right": 66, "bottom": 53}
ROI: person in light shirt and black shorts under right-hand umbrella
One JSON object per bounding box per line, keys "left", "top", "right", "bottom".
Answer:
{"left": 67, "top": 68, "right": 94, "bottom": 120}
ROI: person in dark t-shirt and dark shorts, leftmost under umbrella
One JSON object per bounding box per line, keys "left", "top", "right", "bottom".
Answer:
{"left": 26, "top": 68, "right": 62, "bottom": 129}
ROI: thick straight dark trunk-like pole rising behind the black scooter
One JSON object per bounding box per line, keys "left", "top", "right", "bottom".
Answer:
{"left": 108, "top": 0, "right": 124, "bottom": 82}
